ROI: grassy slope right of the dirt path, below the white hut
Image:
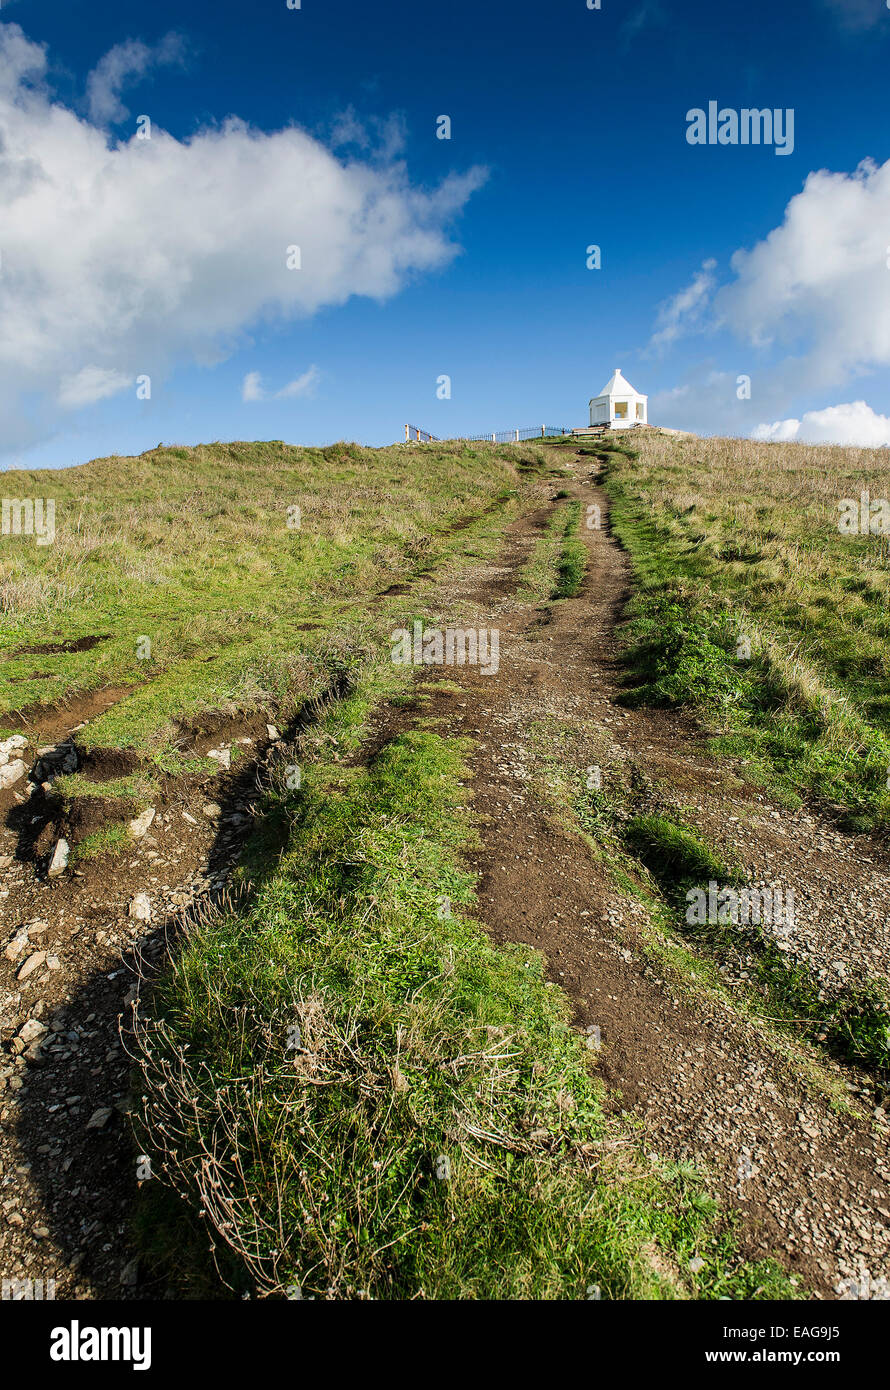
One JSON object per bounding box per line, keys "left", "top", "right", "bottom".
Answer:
{"left": 602, "top": 435, "right": 890, "bottom": 830}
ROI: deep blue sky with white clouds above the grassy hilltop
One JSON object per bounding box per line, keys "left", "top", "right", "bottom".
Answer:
{"left": 0, "top": 0, "right": 890, "bottom": 467}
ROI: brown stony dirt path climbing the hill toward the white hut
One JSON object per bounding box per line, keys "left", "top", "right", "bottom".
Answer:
{"left": 361, "top": 457, "right": 890, "bottom": 1298}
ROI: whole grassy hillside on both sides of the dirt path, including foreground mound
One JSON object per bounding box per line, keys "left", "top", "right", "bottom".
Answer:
{"left": 13, "top": 431, "right": 890, "bottom": 1298}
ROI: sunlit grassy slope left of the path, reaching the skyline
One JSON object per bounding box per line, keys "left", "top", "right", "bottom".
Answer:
{"left": 0, "top": 441, "right": 531, "bottom": 759}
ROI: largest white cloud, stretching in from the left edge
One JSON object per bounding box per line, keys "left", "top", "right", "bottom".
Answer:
{"left": 0, "top": 24, "right": 485, "bottom": 449}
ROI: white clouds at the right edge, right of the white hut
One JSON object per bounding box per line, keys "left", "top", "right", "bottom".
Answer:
{"left": 649, "top": 160, "right": 890, "bottom": 443}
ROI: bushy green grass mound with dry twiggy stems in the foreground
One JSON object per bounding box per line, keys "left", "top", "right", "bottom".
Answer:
{"left": 133, "top": 676, "right": 795, "bottom": 1300}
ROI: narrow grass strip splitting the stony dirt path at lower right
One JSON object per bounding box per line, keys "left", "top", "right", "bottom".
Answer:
{"left": 514, "top": 717, "right": 890, "bottom": 1095}
